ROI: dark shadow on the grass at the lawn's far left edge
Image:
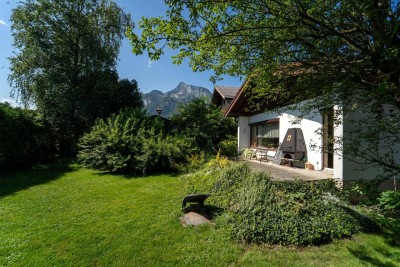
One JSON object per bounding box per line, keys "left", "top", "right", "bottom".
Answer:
{"left": 0, "top": 159, "right": 76, "bottom": 198}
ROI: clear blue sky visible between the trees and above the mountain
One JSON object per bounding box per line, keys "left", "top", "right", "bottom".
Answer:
{"left": 0, "top": 0, "right": 242, "bottom": 107}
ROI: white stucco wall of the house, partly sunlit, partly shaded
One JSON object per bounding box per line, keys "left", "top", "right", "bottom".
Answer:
{"left": 234, "top": 98, "right": 400, "bottom": 186}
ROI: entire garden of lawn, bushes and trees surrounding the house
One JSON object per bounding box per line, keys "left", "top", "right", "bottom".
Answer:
{"left": 0, "top": 0, "right": 400, "bottom": 266}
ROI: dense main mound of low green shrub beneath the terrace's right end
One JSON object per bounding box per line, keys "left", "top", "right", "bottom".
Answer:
{"left": 232, "top": 177, "right": 372, "bottom": 245}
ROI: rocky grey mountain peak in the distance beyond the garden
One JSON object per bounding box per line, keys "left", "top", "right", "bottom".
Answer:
{"left": 142, "top": 82, "right": 211, "bottom": 117}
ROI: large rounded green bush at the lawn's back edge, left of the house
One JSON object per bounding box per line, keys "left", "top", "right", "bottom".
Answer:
{"left": 78, "top": 109, "right": 192, "bottom": 174}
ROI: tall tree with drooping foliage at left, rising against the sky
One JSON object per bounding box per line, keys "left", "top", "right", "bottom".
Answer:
{"left": 9, "top": 0, "right": 130, "bottom": 155}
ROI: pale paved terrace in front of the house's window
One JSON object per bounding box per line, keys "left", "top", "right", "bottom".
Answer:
{"left": 245, "top": 160, "right": 333, "bottom": 181}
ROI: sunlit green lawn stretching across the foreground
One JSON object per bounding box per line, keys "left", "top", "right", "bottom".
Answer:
{"left": 0, "top": 164, "right": 400, "bottom": 266}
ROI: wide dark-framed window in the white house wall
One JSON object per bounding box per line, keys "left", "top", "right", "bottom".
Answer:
{"left": 250, "top": 120, "right": 279, "bottom": 148}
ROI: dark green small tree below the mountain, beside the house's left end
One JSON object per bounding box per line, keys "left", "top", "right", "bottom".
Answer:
{"left": 171, "top": 98, "right": 236, "bottom": 153}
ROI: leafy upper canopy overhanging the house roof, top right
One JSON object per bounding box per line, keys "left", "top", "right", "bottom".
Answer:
{"left": 128, "top": 0, "right": 400, "bottom": 106}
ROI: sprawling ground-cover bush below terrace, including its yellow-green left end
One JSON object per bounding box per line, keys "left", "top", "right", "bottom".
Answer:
{"left": 184, "top": 164, "right": 374, "bottom": 245}
